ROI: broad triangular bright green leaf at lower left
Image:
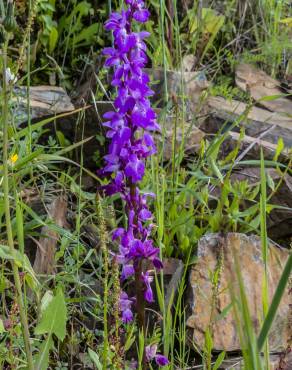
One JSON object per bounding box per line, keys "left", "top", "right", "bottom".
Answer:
{"left": 35, "top": 289, "right": 67, "bottom": 341}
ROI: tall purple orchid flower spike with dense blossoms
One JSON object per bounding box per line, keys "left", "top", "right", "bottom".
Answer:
{"left": 100, "top": 0, "right": 167, "bottom": 369}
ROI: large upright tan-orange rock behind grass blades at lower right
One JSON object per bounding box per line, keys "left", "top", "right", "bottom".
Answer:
{"left": 187, "top": 233, "right": 291, "bottom": 351}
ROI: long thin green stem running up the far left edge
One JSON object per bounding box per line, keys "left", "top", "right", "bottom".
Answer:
{"left": 2, "top": 41, "right": 33, "bottom": 370}
